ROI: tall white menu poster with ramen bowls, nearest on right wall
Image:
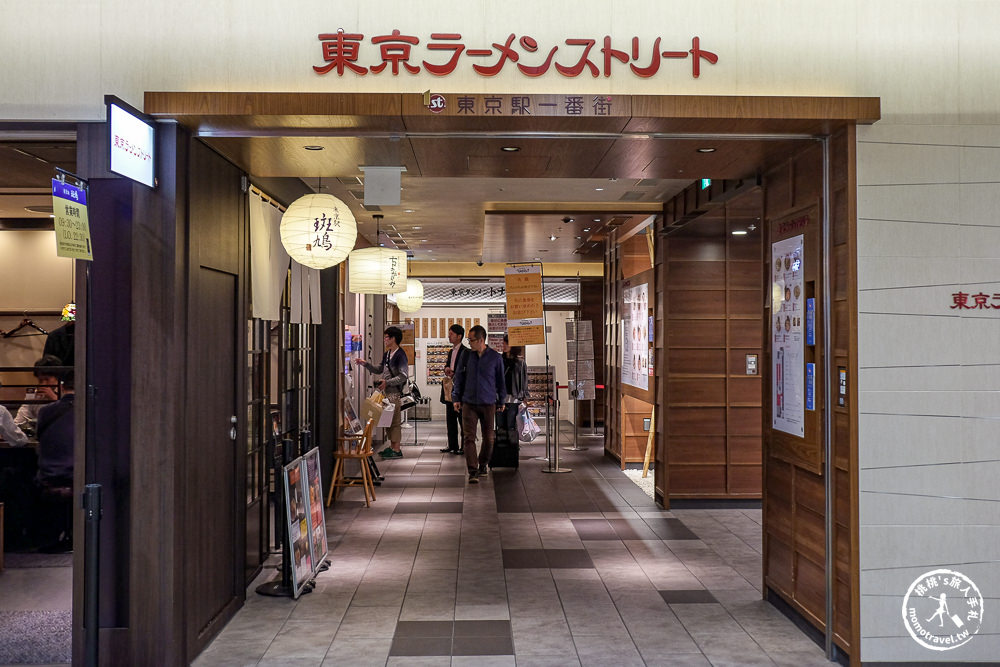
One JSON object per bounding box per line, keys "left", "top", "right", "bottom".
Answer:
{"left": 771, "top": 234, "right": 806, "bottom": 438}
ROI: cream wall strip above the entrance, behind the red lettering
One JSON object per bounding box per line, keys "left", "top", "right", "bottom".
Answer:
{"left": 0, "top": 0, "right": 1000, "bottom": 123}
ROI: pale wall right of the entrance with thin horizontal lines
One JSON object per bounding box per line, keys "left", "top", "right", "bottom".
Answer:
{"left": 858, "top": 124, "right": 1000, "bottom": 661}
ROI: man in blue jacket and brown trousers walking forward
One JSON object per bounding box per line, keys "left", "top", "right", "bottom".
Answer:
{"left": 451, "top": 324, "right": 507, "bottom": 484}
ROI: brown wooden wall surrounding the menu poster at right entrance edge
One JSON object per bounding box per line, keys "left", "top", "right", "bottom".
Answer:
{"left": 760, "top": 127, "right": 858, "bottom": 653}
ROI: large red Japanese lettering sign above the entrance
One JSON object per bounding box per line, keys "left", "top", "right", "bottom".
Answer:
{"left": 313, "top": 29, "right": 719, "bottom": 79}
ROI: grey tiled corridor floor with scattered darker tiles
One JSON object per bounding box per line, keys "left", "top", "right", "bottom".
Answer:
{"left": 195, "top": 424, "right": 830, "bottom": 667}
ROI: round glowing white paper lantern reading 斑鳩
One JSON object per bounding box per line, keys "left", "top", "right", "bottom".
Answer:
{"left": 279, "top": 195, "right": 358, "bottom": 269}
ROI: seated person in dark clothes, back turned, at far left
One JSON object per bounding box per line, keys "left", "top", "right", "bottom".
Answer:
{"left": 35, "top": 370, "right": 75, "bottom": 551}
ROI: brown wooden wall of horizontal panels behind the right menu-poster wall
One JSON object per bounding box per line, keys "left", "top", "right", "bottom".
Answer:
{"left": 664, "top": 190, "right": 763, "bottom": 498}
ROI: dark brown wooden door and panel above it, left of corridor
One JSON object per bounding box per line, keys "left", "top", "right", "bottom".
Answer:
{"left": 184, "top": 142, "right": 247, "bottom": 660}
